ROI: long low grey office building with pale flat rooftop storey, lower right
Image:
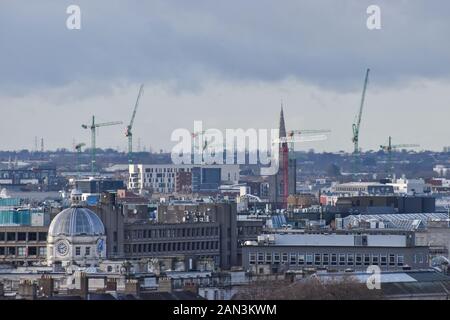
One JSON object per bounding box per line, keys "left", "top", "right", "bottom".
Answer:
{"left": 242, "top": 232, "right": 429, "bottom": 274}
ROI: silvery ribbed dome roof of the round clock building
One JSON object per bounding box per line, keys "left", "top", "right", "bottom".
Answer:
{"left": 48, "top": 206, "right": 105, "bottom": 237}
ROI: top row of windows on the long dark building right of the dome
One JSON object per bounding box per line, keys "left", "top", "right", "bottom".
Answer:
{"left": 125, "top": 227, "right": 219, "bottom": 240}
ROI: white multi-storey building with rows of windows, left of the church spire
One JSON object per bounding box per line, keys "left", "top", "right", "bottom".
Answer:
{"left": 128, "top": 164, "right": 239, "bottom": 193}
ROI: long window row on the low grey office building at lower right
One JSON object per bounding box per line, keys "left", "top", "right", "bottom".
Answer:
{"left": 248, "top": 252, "right": 420, "bottom": 266}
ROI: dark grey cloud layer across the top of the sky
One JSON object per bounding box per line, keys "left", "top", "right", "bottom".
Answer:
{"left": 0, "top": 0, "right": 450, "bottom": 94}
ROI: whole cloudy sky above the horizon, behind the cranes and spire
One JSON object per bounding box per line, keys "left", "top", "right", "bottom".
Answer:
{"left": 0, "top": 0, "right": 450, "bottom": 151}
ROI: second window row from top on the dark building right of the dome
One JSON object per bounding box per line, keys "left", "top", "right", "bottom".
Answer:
{"left": 124, "top": 241, "right": 219, "bottom": 253}
